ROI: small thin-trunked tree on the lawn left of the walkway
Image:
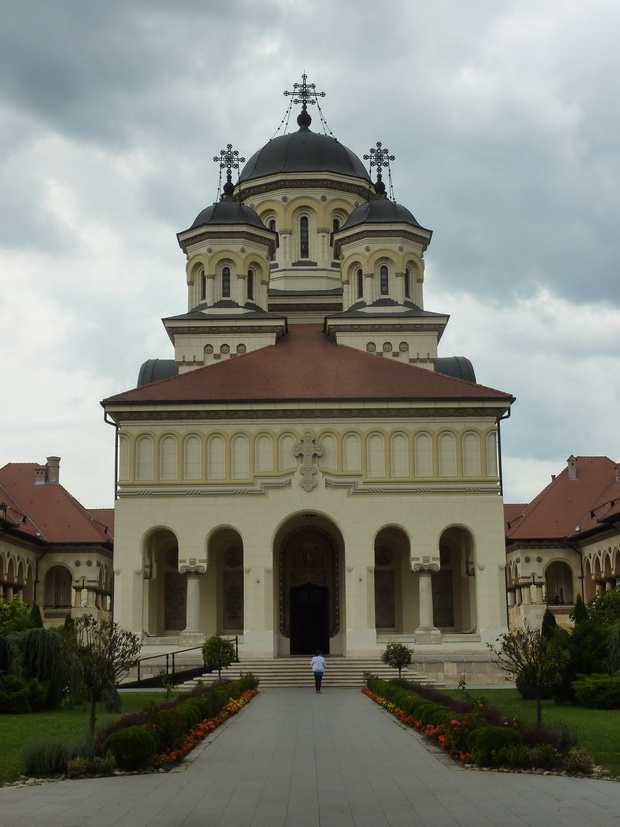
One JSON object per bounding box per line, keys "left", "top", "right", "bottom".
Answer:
{"left": 62, "top": 615, "right": 140, "bottom": 740}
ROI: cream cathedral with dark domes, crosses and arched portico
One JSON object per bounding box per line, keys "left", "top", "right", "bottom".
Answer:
{"left": 102, "top": 75, "right": 514, "bottom": 675}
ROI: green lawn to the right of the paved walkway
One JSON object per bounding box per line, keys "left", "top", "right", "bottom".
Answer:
{"left": 442, "top": 689, "right": 620, "bottom": 776}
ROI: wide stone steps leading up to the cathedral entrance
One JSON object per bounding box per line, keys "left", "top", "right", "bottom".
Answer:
{"left": 179, "top": 655, "right": 438, "bottom": 691}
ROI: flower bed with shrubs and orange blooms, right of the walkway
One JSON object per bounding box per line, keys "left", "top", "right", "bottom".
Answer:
{"left": 362, "top": 677, "right": 593, "bottom": 775}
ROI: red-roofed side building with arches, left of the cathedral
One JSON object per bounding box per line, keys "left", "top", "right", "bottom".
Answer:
{"left": 0, "top": 457, "right": 114, "bottom": 626}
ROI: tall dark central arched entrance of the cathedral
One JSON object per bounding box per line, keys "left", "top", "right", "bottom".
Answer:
{"left": 278, "top": 524, "right": 341, "bottom": 655}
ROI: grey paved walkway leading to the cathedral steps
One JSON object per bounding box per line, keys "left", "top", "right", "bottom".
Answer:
{"left": 0, "top": 687, "right": 620, "bottom": 827}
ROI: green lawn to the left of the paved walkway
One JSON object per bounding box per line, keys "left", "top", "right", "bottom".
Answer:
{"left": 0, "top": 691, "right": 166, "bottom": 784}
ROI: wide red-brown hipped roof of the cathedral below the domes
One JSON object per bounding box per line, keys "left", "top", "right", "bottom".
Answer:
{"left": 103, "top": 325, "right": 514, "bottom": 405}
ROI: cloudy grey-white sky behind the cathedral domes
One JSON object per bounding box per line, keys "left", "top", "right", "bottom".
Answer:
{"left": 0, "top": 0, "right": 620, "bottom": 507}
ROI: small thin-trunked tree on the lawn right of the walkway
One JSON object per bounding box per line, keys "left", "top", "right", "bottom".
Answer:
{"left": 487, "top": 625, "right": 570, "bottom": 726}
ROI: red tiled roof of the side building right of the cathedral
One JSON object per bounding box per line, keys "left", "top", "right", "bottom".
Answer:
{"left": 504, "top": 457, "right": 620, "bottom": 541}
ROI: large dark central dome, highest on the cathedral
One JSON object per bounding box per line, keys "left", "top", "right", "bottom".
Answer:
{"left": 239, "top": 126, "right": 370, "bottom": 184}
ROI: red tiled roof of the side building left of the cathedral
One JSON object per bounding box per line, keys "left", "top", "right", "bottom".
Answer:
{"left": 0, "top": 462, "right": 112, "bottom": 543}
